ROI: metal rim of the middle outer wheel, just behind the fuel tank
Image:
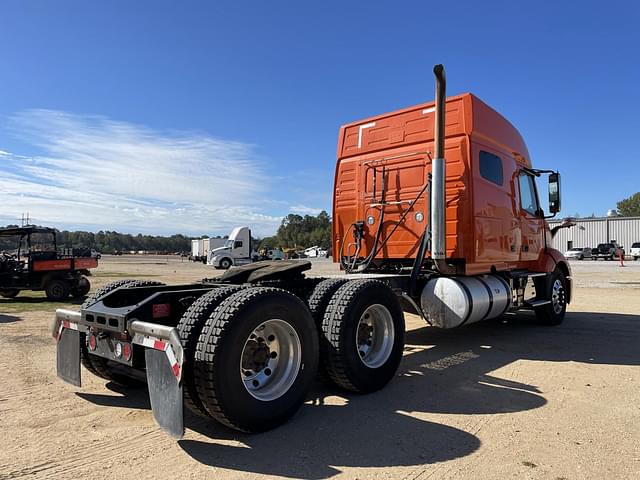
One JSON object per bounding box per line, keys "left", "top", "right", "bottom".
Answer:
{"left": 356, "top": 304, "right": 395, "bottom": 368}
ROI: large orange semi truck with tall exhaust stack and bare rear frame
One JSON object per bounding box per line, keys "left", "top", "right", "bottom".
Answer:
{"left": 54, "top": 65, "right": 571, "bottom": 437}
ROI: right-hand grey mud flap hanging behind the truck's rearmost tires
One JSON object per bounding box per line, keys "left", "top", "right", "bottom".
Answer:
{"left": 144, "top": 348, "right": 184, "bottom": 438}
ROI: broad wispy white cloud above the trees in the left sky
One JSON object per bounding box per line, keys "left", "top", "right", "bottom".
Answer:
{"left": 0, "top": 110, "right": 281, "bottom": 235}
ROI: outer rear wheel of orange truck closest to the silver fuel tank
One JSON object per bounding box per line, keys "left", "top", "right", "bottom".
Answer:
{"left": 322, "top": 280, "right": 405, "bottom": 393}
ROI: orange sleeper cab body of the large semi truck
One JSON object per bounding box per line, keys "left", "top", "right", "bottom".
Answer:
{"left": 333, "top": 93, "right": 562, "bottom": 275}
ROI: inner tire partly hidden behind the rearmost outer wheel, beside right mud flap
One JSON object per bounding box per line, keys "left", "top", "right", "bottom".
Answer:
{"left": 177, "top": 285, "right": 243, "bottom": 417}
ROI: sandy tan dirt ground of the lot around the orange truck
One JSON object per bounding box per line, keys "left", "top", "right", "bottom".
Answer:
{"left": 0, "top": 256, "right": 640, "bottom": 480}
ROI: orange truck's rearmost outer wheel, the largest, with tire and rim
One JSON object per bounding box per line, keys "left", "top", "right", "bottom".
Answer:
{"left": 194, "top": 287, "right": 318, "bottom": 432}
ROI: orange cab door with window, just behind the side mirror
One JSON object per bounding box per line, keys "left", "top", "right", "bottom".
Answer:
{"left": 518, "top": 170, "right": 544, "bottom": 261}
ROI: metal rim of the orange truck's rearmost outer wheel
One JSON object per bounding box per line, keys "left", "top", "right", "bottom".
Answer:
{"left": 240, "top": 319, "right": 302, "bottom": 402}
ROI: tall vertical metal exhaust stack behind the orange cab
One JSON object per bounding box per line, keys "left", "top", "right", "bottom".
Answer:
{"left": 431, "top": 64, "right": 456, "bottom": 274}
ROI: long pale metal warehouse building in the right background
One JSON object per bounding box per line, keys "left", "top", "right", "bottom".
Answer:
{"left": 549, "top": 217, "right": 640, "bottom": 252}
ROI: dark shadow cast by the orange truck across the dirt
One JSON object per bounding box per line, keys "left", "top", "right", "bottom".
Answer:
{"left": 79, "top": 313, "right": 640, "bottom": 479}
